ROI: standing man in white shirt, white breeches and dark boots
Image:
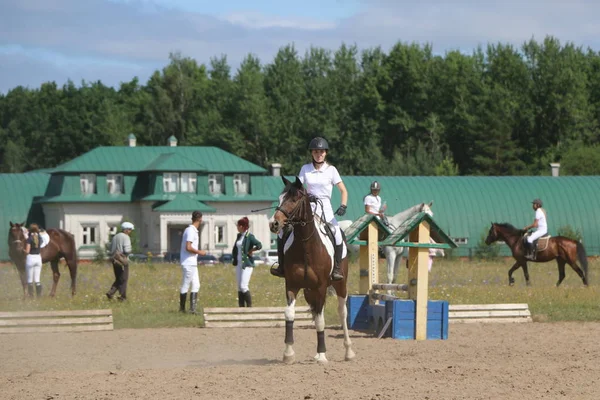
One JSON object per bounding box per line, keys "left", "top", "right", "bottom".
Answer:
{"left": 179, "top": 211, "right": 206, "bottom": 314}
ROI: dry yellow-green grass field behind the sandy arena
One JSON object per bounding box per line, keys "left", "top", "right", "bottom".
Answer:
{"left": 0, "top": 259, "right": 600, "bottom": 329}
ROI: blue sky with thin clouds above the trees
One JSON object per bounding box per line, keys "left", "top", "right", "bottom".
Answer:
{"left": 0, "top": 0, "right": 600, "bottom": 94}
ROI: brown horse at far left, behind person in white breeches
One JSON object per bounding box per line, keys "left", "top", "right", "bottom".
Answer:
{"left": 8, "top": 222, "right": 77, "bottom": 297}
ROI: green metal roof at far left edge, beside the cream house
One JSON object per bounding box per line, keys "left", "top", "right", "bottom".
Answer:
{"left": 0, "top": 172, "right": 50, "bottom": 260}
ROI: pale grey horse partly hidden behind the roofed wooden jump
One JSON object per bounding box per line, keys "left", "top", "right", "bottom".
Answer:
{"left": 338, "top": 201, "right": 433, "bottom": 283}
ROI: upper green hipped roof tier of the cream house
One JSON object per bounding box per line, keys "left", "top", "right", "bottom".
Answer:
{"left": 54, "top": 146, "right": 267, "bottom": 173}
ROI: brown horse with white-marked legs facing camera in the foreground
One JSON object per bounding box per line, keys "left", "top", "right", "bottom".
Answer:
{"left": 270, "top": 176, "right": 355, "bottom": 363}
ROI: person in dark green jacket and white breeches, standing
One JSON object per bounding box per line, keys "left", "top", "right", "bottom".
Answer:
{"left": 231, "top": 217, "right": 262, "bottom": 307}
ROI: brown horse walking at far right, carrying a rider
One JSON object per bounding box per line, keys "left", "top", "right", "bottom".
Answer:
{"left": 485, "top": 222, "right": 588, "bottom": 286}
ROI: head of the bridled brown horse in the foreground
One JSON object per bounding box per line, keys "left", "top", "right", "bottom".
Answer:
{"left": 269, "top": 176, "right": 312, "bottom": 233}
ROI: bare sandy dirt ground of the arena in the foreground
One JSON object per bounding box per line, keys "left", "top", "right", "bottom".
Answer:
{"left": 0, "top": 323, "right": 600, "bottom": 400}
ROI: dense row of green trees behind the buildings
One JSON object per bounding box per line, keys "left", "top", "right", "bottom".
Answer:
{"left": 0, "top": 36, "right": 600, "bottom": 175}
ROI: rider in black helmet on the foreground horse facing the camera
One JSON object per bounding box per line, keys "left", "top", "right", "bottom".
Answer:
{"left": 271, "top": 137, "right": 348, "bottom": 281}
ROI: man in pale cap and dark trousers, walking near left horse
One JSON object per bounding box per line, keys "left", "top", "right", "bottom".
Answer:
{"left": 106, "top": 221, "right": 135, "bottom": 301}
